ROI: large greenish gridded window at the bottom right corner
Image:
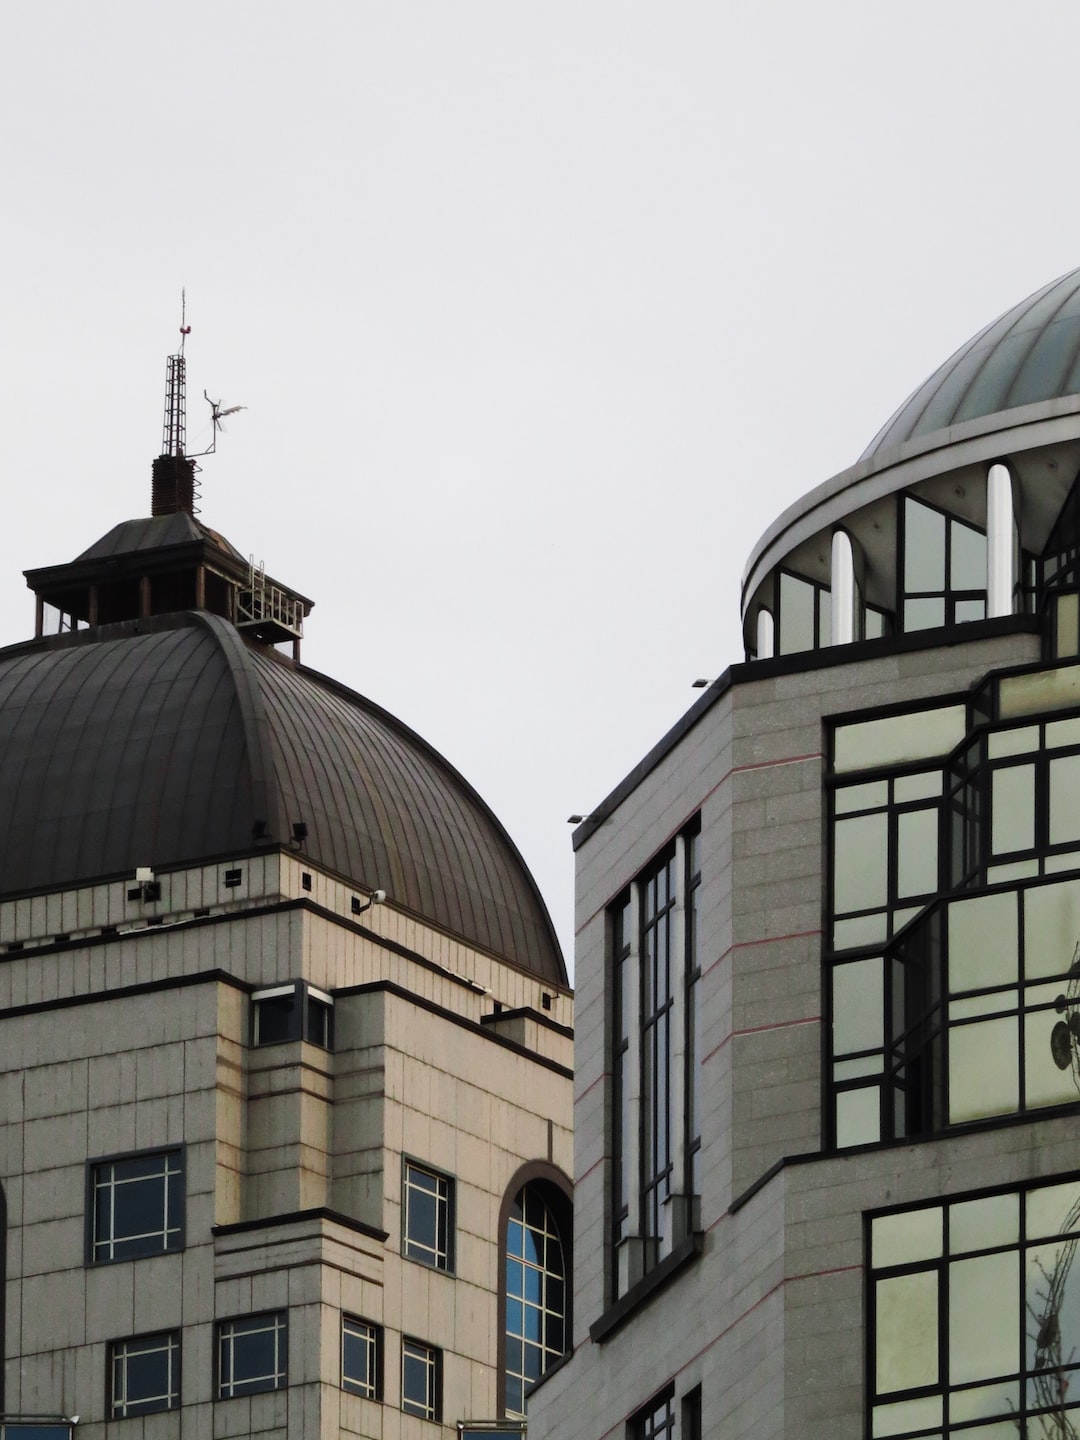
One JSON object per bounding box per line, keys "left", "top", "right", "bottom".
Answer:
{"left": 867, "top": 1179, "right": 1080, "bottom": 1440}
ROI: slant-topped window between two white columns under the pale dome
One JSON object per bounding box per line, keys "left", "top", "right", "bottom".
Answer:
{"left": 903, "top": 495, "right": 986, "bottom": 631}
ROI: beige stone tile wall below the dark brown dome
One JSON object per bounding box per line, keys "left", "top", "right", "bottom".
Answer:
{"left": 0, "top": 855, "right": 573, "bottom": 1440}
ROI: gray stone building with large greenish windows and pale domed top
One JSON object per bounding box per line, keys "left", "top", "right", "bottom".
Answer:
{"left": 530, "top": 271, "right": 1080, "bottom": 1440}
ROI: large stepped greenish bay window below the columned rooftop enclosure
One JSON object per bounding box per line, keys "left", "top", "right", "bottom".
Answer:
{"left": 827, "top": 696, "right": 1080, "bottom": 1146}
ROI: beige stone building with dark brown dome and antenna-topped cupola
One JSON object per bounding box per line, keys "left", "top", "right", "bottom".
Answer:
{"left": 0, "top": 354, "right": 572, "bottom": 1440}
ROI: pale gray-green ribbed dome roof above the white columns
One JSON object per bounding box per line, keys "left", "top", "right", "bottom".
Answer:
{"left": 861, "top": 269, "right": 1080, "bottom": 459}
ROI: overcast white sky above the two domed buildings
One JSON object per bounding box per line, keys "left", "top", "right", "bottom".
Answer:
{"left": 0, "top": 0, "right": 1080, "bottom": 960}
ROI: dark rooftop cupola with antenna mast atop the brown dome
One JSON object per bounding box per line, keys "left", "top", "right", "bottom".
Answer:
{"left": 24, "top": 312, "right": 314, "bottom": 660}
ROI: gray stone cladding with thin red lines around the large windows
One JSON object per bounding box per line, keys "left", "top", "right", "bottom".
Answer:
{"left": 530, "top": 634, "right": 1042, "bottom": 1440}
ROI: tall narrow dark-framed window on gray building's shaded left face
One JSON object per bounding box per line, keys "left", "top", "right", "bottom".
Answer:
{"left": 611, "top": 821, "right": 701, "bottom": 1296}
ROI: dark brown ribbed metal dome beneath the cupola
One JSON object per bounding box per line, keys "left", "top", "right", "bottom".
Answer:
{"left": 0, "top": 611, "right": 566, "bottom": 985}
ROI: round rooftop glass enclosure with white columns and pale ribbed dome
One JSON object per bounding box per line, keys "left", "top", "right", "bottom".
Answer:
{"left": 743, "top": 271, "right": 1080, "bottom": 660}
